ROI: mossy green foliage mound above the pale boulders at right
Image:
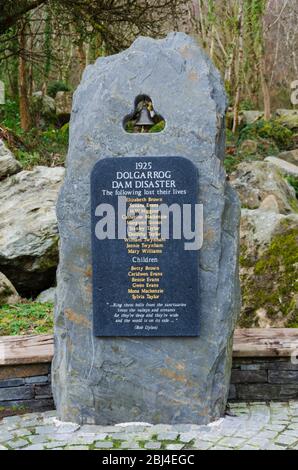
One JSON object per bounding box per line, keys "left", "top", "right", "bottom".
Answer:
{"left": 239, "top": 120, "right": 293, "bottom": 150}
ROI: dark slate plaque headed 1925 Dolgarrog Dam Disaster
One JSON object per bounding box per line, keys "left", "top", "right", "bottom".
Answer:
{"left": 91, "top": 157, "right": 199, "bottom": 336}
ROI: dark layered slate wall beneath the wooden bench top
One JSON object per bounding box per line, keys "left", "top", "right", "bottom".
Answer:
{"left": 0, "top": 357, "right": 298, "bottom": 413}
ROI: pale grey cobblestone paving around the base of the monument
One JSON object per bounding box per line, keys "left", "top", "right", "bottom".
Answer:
{"left": 0, "top": 401, "right": 298, "bottom": 450}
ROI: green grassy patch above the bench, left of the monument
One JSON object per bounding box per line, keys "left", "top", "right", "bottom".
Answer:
{"left": 0, "top": 301, "right": 53, "bottom": 336}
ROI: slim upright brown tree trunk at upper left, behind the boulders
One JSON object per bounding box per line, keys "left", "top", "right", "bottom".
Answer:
{"left": 18, "top": 23, "right": 31, "bottom": 132}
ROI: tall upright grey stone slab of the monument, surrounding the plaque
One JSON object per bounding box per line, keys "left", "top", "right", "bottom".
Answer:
{"left": 52, "top": 33, "right": 240, "bottom": 424}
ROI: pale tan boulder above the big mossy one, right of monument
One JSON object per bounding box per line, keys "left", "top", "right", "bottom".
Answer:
{"left": 230, "top": 161, "right": 297, "bottom": 214}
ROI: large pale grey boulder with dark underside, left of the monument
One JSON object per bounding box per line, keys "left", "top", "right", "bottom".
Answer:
{"left": 0, "top": 166, "right": 64, "bottom": 295}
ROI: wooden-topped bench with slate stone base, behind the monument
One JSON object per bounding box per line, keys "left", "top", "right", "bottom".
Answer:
{"left": 0, "top": 328, "right": 298, "bottom": 411}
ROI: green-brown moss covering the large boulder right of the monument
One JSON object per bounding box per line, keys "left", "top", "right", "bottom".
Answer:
{"left": 240, "top": 227, "right": 298, "bottom": 328}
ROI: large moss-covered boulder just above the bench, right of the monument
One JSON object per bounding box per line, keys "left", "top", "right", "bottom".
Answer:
{"left": 240, "top": 207, "right": 298, "bottom": 328}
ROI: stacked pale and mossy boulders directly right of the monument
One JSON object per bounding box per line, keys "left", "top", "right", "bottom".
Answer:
{"left": 230, "top": 150, "right": 298, "bottom": 328}
